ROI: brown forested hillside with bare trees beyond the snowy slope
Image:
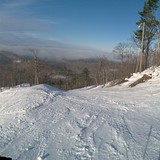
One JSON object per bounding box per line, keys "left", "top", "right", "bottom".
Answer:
{"left": 0, "top": 51, "right": 138, "bottom": 90}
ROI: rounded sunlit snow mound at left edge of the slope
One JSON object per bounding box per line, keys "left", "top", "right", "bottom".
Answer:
{"left": 0, "top": 84, "right": 64, "bottom": 115}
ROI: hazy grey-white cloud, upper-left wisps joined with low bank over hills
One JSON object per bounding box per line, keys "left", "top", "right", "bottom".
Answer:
{"left": 0, "top": 0, "right": 112, "bottom": 59}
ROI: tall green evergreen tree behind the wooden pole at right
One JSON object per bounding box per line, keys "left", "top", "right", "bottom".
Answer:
{"left": 134, "top": 0, "right": 159, "bottom": 69}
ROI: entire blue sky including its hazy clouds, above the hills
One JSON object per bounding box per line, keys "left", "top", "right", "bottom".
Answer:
{"left": 0, "top": 0, "right": 156, "bottom": 58}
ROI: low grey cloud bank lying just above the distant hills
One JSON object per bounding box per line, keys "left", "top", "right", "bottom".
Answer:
{"left": 0, "top": 42, "right": 110, "bottom": 59}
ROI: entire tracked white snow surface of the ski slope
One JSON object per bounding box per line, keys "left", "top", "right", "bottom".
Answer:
{"left": 0, "top": 68, "right": 160, "bottom": 160}
